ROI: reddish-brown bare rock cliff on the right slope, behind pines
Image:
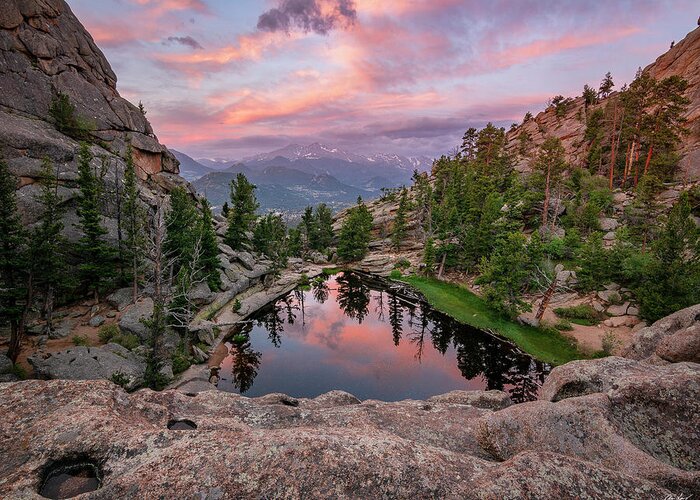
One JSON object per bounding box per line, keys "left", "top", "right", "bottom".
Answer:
{"left": 507, "top": 28, "right": 700, "bottom": 181}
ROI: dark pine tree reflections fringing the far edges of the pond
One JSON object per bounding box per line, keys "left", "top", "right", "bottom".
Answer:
{"left": 221, "top": 272, "right": 549, "bottom": 402}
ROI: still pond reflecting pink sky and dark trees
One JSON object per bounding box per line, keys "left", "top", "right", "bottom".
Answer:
{"left": 218, "top": 272, "right": 550, "bottom": 402}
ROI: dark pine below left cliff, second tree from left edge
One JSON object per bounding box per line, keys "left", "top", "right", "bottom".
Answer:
{"left": 30, "top": 158, "right": 71, "bottom": 332}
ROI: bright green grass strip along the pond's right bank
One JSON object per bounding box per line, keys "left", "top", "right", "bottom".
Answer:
{"left": 401, "top": 276, "right": 586, "bottom": 365}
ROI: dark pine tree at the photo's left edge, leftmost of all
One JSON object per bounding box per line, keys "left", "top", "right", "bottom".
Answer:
{"left": 0, "top": 160, "right": 27, "bottom": 362}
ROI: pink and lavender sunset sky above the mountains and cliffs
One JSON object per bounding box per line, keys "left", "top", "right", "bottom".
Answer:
{"left": 68, "top": 0, "right": 700, "bottom": 159}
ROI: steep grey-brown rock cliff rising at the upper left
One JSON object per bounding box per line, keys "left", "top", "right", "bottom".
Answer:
{"left": 0, "top": 0, "right": 184, "bottom": 239}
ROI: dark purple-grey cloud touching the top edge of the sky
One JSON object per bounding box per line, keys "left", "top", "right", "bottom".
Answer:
{"left": 258, "top": 0, "right": 357, "bottom": 35}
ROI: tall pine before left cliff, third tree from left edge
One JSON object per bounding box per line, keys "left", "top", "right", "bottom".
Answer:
{"left": 77, "top": 143, "right": 113, "bottom": 303}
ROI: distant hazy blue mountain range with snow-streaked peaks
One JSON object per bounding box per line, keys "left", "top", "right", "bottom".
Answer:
{"left": 173, "top": 143, "right": 432, "bottom": 221}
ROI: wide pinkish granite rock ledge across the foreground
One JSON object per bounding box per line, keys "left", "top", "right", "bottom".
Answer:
{"left": 0, "top": 363, "right": 700, "bottom": 499}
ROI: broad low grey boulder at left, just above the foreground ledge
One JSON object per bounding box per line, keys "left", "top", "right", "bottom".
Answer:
{"left": 29, "top": 344, "right": 146, "bottom": 389}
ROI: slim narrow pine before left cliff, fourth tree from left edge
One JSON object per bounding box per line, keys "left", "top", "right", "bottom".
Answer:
{"left": 123, "top": 145, "right": 146, "bottom": 303}
